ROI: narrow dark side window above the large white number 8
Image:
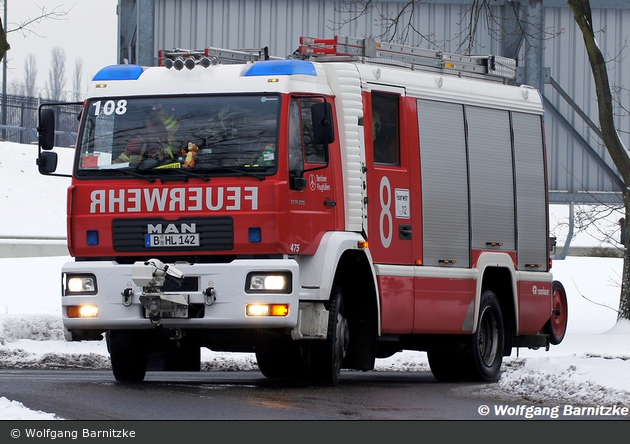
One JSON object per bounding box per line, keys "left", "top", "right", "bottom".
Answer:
{"left": 372, "top": 91, "right": 400, "bottom": 165}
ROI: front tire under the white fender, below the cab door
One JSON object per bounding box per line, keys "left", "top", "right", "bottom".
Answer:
{"left": 309, "top": 287, "right": 350, "bottom": 387}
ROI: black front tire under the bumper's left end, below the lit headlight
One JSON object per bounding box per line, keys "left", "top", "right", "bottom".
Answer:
{"left": 107, "top": 330, "right": 149, "bottom": 382}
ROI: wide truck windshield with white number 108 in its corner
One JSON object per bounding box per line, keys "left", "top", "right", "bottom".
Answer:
{"left": 77, "top": 95, "right": 280, "bottom": 177}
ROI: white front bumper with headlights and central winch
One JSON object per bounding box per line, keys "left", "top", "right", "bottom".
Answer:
{"left": 62, "top": 259, "right": 300, "bottom": 332}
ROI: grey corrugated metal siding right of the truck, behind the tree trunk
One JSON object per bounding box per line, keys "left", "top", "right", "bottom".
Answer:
{"left": 543, "top": 7, "right": 630, "bottom": 192}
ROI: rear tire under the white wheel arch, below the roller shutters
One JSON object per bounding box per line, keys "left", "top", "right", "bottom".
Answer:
{"left": 467, "top": 290, "right": 505, "bottom": 382}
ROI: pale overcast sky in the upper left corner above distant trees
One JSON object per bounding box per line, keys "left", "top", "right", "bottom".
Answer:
{"left": 0, "top": 0, "right": 118, "bottom": 96}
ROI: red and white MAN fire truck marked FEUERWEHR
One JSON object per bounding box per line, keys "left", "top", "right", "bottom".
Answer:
{"left": 37, "top": 36, "right": 567, "bottom": 386}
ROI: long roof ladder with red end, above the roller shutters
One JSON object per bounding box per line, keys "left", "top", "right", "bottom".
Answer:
{"left": 298, "top": 36, "right": 516, "bottom": 82}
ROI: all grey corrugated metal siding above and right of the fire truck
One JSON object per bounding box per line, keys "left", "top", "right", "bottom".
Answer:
{"left": 154, "top": 0, "right": 630, "bottom": 196}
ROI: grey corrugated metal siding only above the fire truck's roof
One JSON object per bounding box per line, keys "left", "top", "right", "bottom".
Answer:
{"left": 155, "top": 0, "right": 500, "bottom": 57}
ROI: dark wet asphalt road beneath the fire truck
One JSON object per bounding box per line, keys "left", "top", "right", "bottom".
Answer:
{"left": 0, "top": 369, "right": 506, "bottom": 421}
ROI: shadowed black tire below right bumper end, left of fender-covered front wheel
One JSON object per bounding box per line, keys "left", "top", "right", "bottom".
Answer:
{"left": 256, "top": 343, "right": 307, "bottom": 380}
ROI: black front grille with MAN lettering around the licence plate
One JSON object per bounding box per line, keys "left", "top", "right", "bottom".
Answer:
{"left": 112, "top": 217, "right": 234, "bottom": 253}
